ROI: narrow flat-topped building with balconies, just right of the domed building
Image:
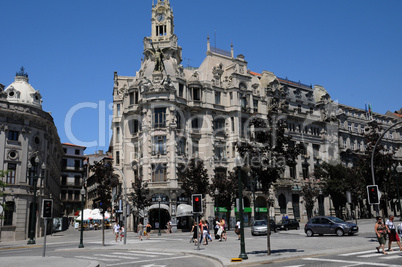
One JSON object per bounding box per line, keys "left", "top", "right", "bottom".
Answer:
{"left": 60, "top": 143, "right": 86, "bottom": 218}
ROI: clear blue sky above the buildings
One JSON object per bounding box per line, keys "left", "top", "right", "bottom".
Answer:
{"left": 0, "top": 0, "right": 402, "bottom": 154}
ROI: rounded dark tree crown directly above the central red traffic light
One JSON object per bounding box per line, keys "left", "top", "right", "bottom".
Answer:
{"left": 179, "top": 158, "right": 209, "bottom": 198}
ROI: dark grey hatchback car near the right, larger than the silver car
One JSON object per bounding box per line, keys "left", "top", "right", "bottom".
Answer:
{"left": 304, "top": 216, "right": 359, "bottom": 236}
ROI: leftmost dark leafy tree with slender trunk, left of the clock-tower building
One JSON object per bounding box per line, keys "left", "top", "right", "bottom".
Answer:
{"left": 89, "top": 161, "right": 121, "bottom": 246}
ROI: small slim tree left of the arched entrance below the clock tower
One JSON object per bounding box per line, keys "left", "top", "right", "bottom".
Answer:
{"left": 129, "top": 177, "right": 150, "bottom": 228}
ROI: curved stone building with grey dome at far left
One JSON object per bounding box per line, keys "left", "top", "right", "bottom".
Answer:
{"left": 0, "top": 68, "right": 63, "bottom": 241}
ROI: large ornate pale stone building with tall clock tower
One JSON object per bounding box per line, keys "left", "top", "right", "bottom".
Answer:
{"left": 111, "top": 0, "right": 402, "bottom": 231}
